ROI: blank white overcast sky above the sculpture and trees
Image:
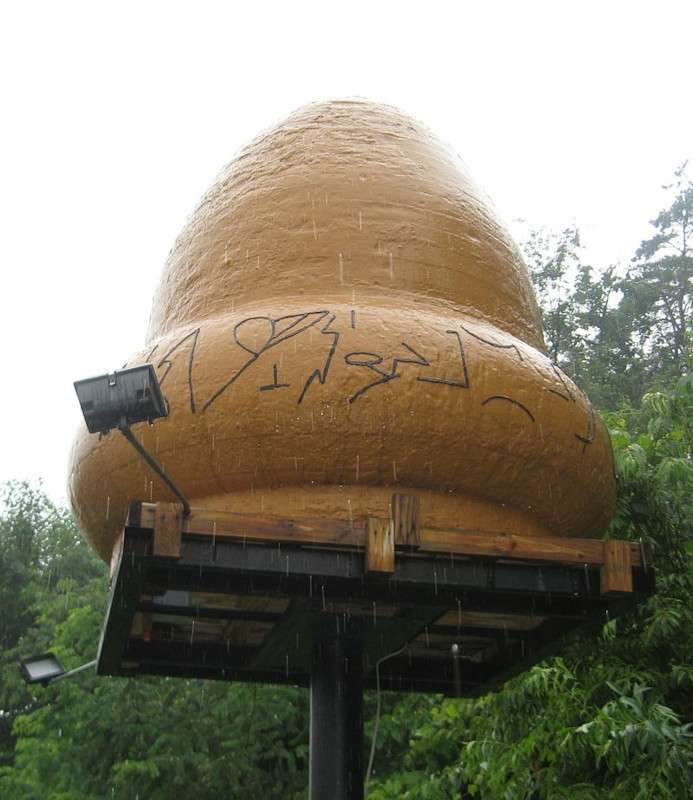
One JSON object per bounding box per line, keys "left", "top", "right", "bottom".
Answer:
{"left": 0, "top": 0, "right": 693, "bottom": 500}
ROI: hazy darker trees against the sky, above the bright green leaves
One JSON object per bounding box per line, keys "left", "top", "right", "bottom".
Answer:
{"left": 524, "top": 164, "right": 693, "bottom": 410}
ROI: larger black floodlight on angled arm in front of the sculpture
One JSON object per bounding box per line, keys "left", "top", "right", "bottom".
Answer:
{"left": 75, "top": 364, "right": 190, "bottom": 516}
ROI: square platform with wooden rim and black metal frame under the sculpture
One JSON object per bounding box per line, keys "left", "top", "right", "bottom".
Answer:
{"left": 98, "top": 495, "right": 654, "bottom": 695}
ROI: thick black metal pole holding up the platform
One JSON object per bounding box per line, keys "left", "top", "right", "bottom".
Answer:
{"left": 310, "top": 634, "right": 363, "bottom": 800}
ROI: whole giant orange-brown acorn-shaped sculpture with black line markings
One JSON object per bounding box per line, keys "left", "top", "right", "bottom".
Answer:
{"left": 69, "top": 101, "right": 615, "bottom": 559}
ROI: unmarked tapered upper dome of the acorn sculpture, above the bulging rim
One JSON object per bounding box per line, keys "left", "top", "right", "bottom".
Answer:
{"left": 149, "top": 100, "right": 544, "bottom": 349}
